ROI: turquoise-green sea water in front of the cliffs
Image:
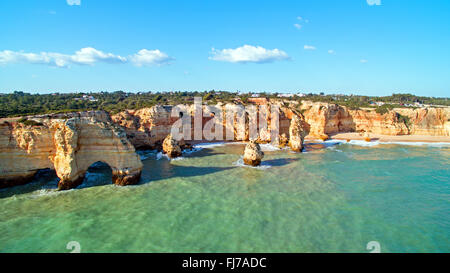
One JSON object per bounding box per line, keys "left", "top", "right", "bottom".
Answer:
{"left": 0, "top": 140, "right": 450, "bottom": 252}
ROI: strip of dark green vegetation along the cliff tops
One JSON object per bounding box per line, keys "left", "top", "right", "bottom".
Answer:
{"left": 0, "top": 90, "right": 450, "bottom": 118}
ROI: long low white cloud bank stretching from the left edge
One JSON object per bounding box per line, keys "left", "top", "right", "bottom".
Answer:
{"left": 0, "top": 47, "right": 172, "bottom": 67}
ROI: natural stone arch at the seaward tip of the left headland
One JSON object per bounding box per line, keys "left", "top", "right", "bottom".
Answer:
{"left": 53, "top": 118, "right": 142, "bottom": 190}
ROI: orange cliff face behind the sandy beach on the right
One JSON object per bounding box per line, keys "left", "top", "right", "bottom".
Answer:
{"left": 301, "top": 101, "right": 450, "bottom": 138}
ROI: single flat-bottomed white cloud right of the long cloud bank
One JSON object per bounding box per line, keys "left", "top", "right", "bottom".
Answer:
{"left": 209, "top": 45, "right": 289, "bottom": 63}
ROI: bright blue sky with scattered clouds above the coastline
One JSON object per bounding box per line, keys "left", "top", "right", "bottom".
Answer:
{"left": 0, "top": 0, "right": 450, "bottom": 97}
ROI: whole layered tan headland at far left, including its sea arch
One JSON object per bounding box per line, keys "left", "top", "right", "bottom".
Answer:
{"left": 0, "top": 114, "right": 142, "bottom": 190}
